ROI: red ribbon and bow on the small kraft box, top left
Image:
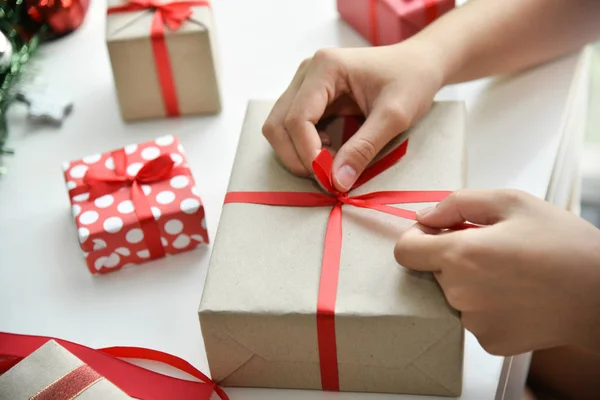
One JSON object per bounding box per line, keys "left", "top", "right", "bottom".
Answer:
{"left": 107, "top": 0, "right": 210, "bottom": 117}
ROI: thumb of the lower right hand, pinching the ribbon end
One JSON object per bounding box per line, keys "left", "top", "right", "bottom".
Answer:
{"left": 417, "top": 189, "right": 521, "bottom": 229}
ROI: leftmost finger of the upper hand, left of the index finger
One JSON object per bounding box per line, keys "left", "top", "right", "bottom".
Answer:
{"left": 262, "top": 59, "right": 311, "bottom": 176}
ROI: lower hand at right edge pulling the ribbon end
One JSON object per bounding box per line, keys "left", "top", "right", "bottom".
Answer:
{"left": 395, "top": 190, "right": 600, "bottom": 355}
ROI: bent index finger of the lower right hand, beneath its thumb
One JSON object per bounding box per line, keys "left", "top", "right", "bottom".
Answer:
{"left": 394, "top": 223, "right": 449, "bottom": 272}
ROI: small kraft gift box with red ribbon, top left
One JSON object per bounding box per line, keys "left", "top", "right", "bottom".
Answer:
{"left": 106, "top": 0, "right": 221, "bottom": 121}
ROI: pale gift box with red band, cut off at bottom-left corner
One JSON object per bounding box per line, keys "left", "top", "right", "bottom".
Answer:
{"left": 0, "top": 340, "right": 131, "bottom": 400}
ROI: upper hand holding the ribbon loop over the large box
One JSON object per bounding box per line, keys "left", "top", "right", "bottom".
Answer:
{"left": 263, "top": 40, "right": 445, "bottom": 192}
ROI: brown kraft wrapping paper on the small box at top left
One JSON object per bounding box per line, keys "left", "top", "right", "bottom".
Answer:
{"left": 106, "top": 0, "right": 221, "bottom": 121}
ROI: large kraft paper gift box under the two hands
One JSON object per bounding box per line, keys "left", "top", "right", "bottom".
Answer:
{"left": 199, "top": 102, "right": 465, "bottom": 396}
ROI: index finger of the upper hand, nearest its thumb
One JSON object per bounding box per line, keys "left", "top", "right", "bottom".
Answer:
{"left": 284, "top": 51, "right": 341, "bottom": 171}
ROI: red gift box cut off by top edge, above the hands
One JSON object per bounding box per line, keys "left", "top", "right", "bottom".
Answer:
{"left": 337, "top": 0, "right": 455, "bottom": 46}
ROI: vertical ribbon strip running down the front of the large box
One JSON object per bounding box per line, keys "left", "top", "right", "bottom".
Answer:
{"left": 317, "top": 204, "right": 342, "bottom": 391}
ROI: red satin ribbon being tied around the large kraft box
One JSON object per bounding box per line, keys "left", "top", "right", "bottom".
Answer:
{"left": 225, "top": 140, "right": 471, "bottom": 391}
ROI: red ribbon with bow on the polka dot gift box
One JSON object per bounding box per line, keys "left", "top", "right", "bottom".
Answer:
{"left": 69, "top": 149, "right": 188, "bottom": 259}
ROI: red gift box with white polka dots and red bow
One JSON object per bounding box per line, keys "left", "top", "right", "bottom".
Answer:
{"left": 63, "top": 136, "right": 209, "bottom": 274}
